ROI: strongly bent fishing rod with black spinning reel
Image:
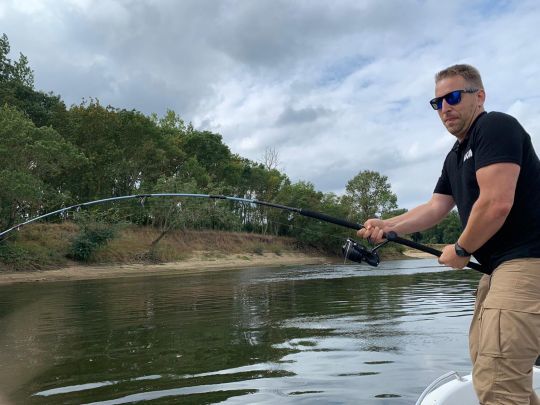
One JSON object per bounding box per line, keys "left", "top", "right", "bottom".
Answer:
{"left": 0, "top": 193, "right": 488, "bottom": 274}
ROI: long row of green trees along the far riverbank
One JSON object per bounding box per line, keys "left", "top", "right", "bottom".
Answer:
{"left": 0, "top": 34, "right": 459, "bottom": 251}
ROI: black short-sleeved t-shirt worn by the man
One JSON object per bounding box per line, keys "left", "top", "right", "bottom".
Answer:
{"left": 434, "top": 112, "right": 540, "bottom": 271}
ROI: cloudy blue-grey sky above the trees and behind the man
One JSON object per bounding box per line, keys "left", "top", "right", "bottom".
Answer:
{"left": 0, "top": 0, "right": 540, "bottom": 209}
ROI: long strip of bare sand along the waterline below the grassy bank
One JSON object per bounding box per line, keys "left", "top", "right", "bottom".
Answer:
{"left": 0, "top": 252, "right": 336, "bottom": 285}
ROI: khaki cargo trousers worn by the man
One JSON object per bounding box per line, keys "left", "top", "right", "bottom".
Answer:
{"left": 469, "top": 259, "right": 540, "bottom": 405}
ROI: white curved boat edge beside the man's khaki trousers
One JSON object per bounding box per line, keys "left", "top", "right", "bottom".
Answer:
{"left": 416, "top": 366, "right": 540, "bottom": 405}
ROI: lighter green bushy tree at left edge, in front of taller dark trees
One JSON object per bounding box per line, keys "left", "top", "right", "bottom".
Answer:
{"left": 0, "top": 105, "right": 85, "bottom": 228}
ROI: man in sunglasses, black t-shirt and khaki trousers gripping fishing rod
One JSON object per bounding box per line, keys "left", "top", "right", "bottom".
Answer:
{"left": 358, "top": 65, "right": 540, "bottom": 405}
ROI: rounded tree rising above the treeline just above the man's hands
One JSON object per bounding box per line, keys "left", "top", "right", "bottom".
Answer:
{"left": 342, "top": 170, "right": 397, "bottom": 223}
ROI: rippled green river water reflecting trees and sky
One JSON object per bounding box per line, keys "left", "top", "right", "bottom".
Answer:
{"left": 0, "top": 259, "right": 479, "bottom": 405}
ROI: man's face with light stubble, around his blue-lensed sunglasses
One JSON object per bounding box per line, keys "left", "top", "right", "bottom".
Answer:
{"left": 435, "top": 76, "right": 485, "bottom": 140}
